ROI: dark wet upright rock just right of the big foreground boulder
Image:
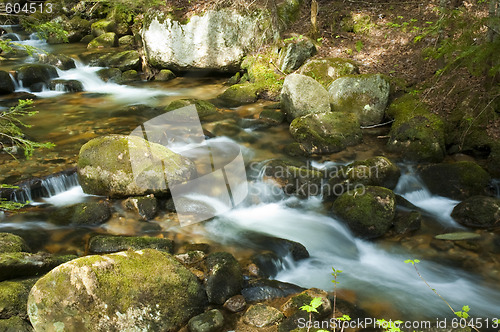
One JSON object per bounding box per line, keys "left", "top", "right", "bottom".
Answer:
{"left": 205, "top": 252, "right": 243, "bottom": 304}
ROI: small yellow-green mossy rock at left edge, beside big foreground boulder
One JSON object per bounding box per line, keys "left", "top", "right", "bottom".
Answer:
{"left": 0, "top": 278, "right": 38, "bottom": 320}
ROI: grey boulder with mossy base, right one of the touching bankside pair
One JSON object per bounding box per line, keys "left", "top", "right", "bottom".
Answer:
{"left": 328, "top": 74, "right": 390, "bottom": 126}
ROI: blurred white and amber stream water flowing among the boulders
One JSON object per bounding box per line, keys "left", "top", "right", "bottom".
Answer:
{"left": 0, "top": 27, "right": 500, "bottom": 319}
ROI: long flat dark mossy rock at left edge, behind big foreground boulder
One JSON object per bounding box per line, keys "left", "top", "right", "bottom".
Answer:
{"left": 0, "top": 252, "right": 76, "bottom": 281}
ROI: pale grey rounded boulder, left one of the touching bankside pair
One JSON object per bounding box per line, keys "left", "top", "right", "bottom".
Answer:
{"left": 281, "top": 74, "right": 331, "bottom": 122}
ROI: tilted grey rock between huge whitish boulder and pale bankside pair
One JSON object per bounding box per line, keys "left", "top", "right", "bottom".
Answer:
{"left": 278, "top": 39, "right": 317, "bottom": 74}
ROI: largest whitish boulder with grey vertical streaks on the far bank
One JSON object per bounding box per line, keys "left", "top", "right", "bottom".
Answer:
{"left": 142, "top": 9, "right": 270, "bottom": 72}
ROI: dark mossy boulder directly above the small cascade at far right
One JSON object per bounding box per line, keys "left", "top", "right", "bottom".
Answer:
{"left": 420, "top": 161, "right": 491, "bottom": 200}
